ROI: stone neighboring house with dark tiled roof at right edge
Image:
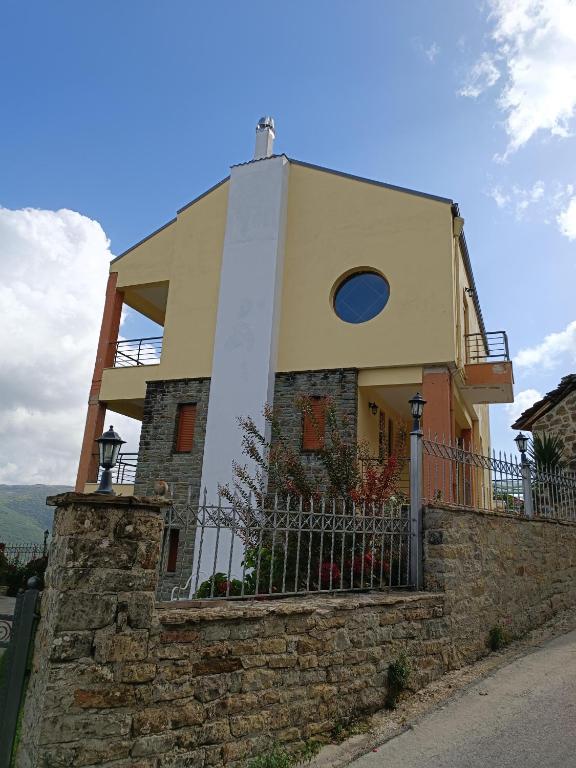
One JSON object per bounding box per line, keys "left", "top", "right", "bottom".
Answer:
{"left": 512, "top": 373, "right": 576, "bottom": 471}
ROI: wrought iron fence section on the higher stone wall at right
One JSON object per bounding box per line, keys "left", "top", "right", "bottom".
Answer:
{"left": 422, "top": 437, "right": 576, "bottom": 520}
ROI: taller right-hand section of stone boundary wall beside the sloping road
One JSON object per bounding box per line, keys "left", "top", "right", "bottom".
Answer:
{"left": 423, "top": 508, "right": 576, "bottom": 662}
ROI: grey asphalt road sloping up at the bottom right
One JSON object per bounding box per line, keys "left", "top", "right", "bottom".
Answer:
{"left": 351, "top": 631, "right": 576, "bottom": 768}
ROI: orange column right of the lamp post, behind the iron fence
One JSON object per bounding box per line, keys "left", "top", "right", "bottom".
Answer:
{"left": 422, "top": 367, "right": 455, "bottom": 501}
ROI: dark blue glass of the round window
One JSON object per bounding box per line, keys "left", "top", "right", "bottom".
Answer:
{"left": 334, "top": 272, "right": 390, "bottom": 323}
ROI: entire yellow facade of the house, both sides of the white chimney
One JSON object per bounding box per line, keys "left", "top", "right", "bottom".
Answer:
{"left": 99, "top": 161, "right": 512, "bottom": 449}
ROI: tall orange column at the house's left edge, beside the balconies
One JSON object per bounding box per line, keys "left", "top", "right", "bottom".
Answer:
{"left": 76, "top": 272, "right": 123, "bottom": 493}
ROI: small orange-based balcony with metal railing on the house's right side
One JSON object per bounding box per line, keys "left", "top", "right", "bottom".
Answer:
{"left": 462, "top": 331, "right": 514, "bottom": 404}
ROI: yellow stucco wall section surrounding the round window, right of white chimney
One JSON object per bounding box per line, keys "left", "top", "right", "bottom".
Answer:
{"left": 278, "top": 164, "right": 455, "bottom": 371}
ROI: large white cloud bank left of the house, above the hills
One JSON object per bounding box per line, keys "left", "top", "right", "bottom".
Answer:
{"left": 0, "top": 208, "right": 139, "bottom": 484}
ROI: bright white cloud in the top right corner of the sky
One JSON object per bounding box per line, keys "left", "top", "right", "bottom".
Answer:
{"left": 460, "top": 0, "right": 576, "bottom": 159}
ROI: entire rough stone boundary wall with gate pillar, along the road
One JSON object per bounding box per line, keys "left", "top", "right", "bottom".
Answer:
{"left": 17, "top": 494, "right": 576, "bottom": 768}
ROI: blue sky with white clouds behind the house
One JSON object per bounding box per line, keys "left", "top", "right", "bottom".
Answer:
{"left": 0, "top": 0, "right": 576, "bottom": 483}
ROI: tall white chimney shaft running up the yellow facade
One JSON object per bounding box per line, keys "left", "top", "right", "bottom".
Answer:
{"left": 191, "top": 155, "right": 289, "bottom": 592}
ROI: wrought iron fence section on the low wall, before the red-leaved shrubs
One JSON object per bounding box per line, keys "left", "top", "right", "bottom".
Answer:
{"left": 166, "top": 498, "right": 412, "bottom": 599}
